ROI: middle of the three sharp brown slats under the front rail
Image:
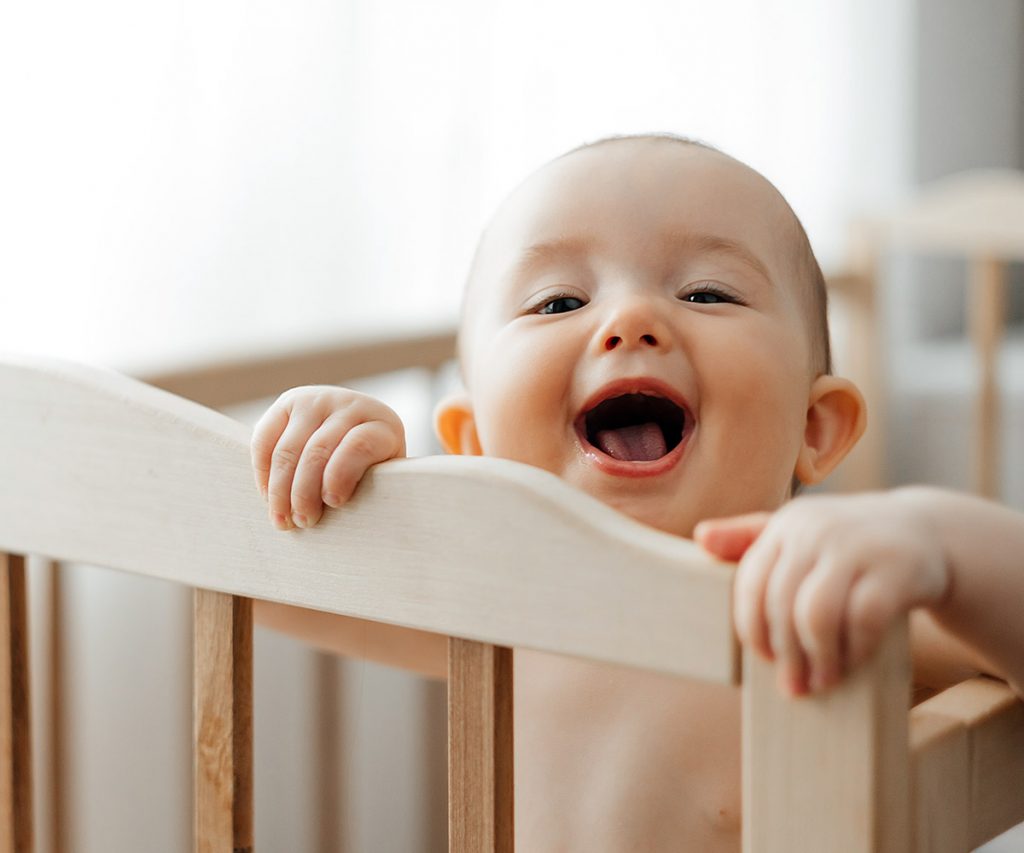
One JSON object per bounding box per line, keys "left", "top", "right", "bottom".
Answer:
{"left": 193, "top": 590, "right": 253, "bottom": 853}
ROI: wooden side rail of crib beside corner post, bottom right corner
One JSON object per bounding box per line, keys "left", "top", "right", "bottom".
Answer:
{"left": 910, "top": 678, "right": 1024, "bottom": 850}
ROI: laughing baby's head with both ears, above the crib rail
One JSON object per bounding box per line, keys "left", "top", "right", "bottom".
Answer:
{"left": 437, "top": 136, "right": 864, "bottom": 536}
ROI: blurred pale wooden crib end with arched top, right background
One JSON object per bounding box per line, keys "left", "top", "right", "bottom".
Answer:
{"left": 834, "top": 170, "right": 1024, "bottom": 498}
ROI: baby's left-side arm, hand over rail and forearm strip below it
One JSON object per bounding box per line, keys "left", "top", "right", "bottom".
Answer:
{"left": 251, "top": 385, "right": 447, "bottom": 678}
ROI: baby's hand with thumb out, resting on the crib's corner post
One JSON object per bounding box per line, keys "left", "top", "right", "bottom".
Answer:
{"left": 694, "top": 492, "right": 949, "bottom": 695}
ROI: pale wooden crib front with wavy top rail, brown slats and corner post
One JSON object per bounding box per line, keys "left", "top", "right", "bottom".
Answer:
{"left": 0, "top": 342, "right": 1024, "bottom": 853}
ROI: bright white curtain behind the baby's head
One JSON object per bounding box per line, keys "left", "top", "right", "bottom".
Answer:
{"left": 0, "top": 0, "right": 910, "bottom": 370}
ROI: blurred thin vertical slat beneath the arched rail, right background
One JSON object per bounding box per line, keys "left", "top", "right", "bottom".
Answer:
{"left": 967, "top": 257, "right": 1006, "bottom": 499}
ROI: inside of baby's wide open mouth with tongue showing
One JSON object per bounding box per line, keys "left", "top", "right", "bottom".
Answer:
{"left": 578, "top": 393, "right": 687, "bottom": 462}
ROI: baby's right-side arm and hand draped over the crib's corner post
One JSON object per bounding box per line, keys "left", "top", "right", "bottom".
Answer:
{"left": 695, "top": 487, "right": 1024, "bottom": 696}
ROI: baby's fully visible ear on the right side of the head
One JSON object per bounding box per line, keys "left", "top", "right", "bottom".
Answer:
{"left": 795, "top": 376, "right": 867, "bottom": 485}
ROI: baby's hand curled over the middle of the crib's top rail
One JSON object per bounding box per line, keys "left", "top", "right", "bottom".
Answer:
{"left": 251, "top": 385, "right": 406, "bottom": 530}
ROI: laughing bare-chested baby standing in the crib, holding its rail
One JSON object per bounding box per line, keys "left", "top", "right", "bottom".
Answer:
{"left": 252, "top": 135, "right": 1024, "bottom": 851}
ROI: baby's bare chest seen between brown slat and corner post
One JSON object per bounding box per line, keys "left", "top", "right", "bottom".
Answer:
{"left": 515, "top": 651, "right": 740, "bottom": 851}
